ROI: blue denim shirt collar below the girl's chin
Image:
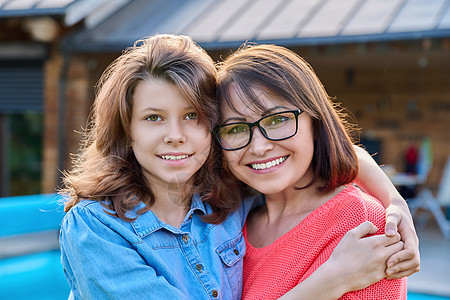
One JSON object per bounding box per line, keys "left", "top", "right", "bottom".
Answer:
{"left": 127, "top": 194, "right": 206, "bottom": 238}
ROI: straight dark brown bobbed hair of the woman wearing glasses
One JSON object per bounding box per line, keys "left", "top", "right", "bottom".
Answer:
{"left": 216, "top": 45, "right": 358, "bottom": 191}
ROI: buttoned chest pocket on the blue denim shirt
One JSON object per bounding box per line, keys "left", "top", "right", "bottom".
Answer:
{"left": 216, "top": 233, "right": 246, "bottom": 299}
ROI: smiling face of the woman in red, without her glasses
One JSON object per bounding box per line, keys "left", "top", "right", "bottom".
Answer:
{"left": 221, "top": 93, "right": 314, "bottom": 195}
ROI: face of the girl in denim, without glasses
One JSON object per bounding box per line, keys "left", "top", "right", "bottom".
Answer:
{"left": 130, "top": 79, "right": 211, "bottom": 186}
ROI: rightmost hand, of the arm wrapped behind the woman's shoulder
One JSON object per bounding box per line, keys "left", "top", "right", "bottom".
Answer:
{"left": 385, "top": 199, "right": 420, "bottom": 279}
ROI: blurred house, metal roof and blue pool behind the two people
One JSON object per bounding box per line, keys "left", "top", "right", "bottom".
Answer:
{"left": 0, "top": 0, "right": 450, "bottom": 299}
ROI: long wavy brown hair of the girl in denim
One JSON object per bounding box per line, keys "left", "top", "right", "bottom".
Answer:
{"left": 60, "top": 34, "right": 243, "bottom": 223}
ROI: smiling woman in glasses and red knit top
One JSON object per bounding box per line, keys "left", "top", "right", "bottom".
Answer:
{"left": 214, "top": 45, "right": 414, "bottom": 299}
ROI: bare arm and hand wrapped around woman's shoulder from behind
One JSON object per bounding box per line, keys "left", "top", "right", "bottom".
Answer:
{"left": 354, "top": 146, "right": 420, "bottom": 279}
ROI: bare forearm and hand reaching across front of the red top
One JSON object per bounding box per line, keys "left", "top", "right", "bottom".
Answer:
{"left": 279, "top": 222, "right": 403, "bottom": 300}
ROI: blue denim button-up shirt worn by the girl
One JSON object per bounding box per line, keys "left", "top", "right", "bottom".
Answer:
{"left": 60, "top": 195, "right": 255, "bottom": 300}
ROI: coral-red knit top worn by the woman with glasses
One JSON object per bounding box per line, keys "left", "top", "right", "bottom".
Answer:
{"left": 242, "top": 186, "right": 406, "bottom": 300}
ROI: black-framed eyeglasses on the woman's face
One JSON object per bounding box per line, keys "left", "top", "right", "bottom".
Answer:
{"left": 213, "top": 109, "right": 303, "bottom": 151}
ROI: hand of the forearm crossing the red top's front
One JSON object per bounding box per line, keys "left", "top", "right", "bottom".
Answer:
{"left": 329, "top": 221, "right": 403, "bottom": 292}
